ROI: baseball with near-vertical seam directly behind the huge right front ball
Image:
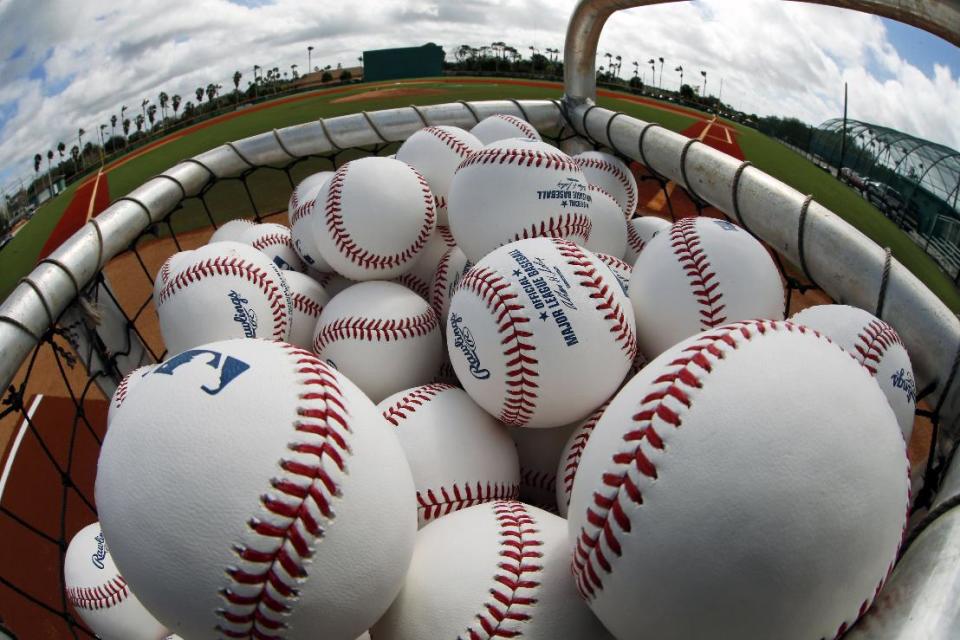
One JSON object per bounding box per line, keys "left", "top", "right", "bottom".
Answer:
{"left": 630, "top": 218, "right": 784, "bottom": 360}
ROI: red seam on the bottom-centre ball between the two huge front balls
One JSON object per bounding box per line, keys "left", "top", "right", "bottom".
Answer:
{"left": 467, "top": 502, "right": 543, "bottom": 640}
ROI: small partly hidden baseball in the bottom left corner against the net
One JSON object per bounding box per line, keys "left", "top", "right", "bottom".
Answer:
{"left": 63, "top": 522, "right": 170, "bottom": 640}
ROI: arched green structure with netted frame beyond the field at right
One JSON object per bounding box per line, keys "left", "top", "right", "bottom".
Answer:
{"left": 808, "top": 118, "right": 960, "bottom": 282}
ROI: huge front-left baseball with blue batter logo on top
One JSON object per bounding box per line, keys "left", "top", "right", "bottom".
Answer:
{"left": 96, "top": 340, "right": 417, "bottom": 640}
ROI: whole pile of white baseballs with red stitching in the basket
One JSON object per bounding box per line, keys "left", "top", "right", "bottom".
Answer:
{"left": 73, "top": 115, "right": 916, "bottom": 640}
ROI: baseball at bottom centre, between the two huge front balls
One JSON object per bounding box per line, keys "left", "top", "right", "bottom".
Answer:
{"left": 372, "top": 501, "right": 610, "bottom": 640}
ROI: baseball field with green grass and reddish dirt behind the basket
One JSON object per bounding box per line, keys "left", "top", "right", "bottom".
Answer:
{"left": 0, "top": 78, "right": 960, "bottom": 311}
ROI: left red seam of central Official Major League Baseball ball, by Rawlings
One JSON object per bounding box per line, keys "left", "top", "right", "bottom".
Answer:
{"left": 457, "top": 267, "right": 540, "bottom": 426}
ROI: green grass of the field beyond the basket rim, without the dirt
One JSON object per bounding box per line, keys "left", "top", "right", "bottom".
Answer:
{"left": 0, "top": 79, "right": 960, "bottom": 311}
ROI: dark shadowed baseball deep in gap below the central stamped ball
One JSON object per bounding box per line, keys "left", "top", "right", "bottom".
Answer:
{"left": 510, "top": 425, "right": 575, "bottom": 513}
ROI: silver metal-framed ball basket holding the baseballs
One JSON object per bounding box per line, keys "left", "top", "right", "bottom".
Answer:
{"left": 0, "top": 0, "right": 960, "bottom": 640}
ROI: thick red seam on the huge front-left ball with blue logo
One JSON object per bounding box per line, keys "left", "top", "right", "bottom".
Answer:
{"left": 216, "top": 345, "right": 351, "bottom": 639}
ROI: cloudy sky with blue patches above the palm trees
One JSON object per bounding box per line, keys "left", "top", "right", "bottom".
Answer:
{"left": 0, "top": 0, "right": 960, "bottom": 190}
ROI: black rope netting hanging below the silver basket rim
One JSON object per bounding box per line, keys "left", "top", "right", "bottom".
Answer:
{"left": 0, "top": 102, "right": 944, "bottom": 638}
